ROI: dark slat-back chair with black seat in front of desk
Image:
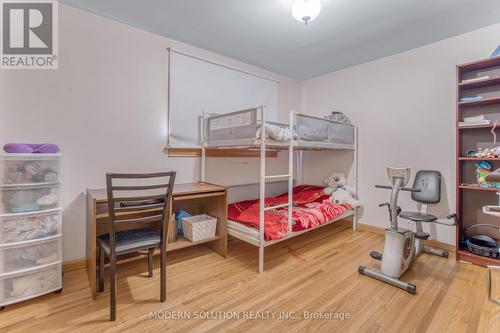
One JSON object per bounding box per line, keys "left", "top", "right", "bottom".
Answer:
{"left": 98, "top": 172, "right": 175, "bottom": 321}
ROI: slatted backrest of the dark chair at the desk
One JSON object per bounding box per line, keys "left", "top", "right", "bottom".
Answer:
{"left": 106, "top": 171, "right": 176, "bottom": 252}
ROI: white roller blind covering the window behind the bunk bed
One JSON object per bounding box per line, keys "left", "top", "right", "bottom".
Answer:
{"left": 168, "top": 50, "right": 278, "bottom": 148}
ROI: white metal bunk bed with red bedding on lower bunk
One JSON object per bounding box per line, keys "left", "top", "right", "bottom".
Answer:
{"left": 201, "top": 106, "right": 357, "bottom": 273}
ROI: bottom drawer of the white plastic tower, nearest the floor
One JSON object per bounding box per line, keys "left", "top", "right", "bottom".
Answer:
{"left": 0, "top": 263, "right": 62, "bottom": 306}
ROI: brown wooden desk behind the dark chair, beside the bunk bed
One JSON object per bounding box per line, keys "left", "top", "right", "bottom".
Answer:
{"left": 86, "top": 183, "right": 227, "bottom": 298}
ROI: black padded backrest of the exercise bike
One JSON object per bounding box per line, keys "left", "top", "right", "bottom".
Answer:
{"left": 411, "top": 170, "right": 441, "bottom": 204}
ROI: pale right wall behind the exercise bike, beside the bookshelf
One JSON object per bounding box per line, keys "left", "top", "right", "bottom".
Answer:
{"left": 302, "top": 24, "right": 500, "bottom": 244}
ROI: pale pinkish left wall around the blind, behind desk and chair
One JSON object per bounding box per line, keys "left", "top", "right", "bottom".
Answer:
{"left": 0, "top": 4, "right": 300, "bottom": 260}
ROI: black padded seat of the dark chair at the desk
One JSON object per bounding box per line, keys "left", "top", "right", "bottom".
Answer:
{"left": 99, "top": 229, "right": 161, "bottom": 254}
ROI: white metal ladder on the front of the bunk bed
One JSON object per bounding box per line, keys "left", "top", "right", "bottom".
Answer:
{"left": 259, "top": 106, "right": 295, "bottom": 273}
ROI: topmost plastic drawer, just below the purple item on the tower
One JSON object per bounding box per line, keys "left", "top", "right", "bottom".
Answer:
{"left": 0, "top": 154, "right": 62, "bottom": 185}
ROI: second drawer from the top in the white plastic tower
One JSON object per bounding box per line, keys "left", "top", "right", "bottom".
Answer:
{"left": 0, "top": 184, "right": 61, "bottom": 214}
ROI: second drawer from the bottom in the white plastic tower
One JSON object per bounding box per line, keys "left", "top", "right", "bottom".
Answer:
{"left": 0, "top": 237, "right": 61, "bottom": 274}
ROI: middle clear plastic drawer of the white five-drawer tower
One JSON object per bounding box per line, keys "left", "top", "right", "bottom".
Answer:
{"left": 0, "top": 208, "right": 62, "bottom": 244}
